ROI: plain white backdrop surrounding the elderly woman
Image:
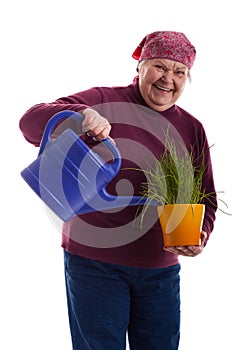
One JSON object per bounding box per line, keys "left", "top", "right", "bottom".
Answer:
{"left": 0, "top": 0, "right": 233, "bottom": 350}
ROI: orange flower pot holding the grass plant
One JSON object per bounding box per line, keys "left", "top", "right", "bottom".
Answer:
{"left": 157, "top": 204, "right": 205, "bottom": 247}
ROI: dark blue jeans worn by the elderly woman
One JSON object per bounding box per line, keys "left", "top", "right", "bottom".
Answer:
{"left": 65, "top": 251, "right": 180, "bottom": 350}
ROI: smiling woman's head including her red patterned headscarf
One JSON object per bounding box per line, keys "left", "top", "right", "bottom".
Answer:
{"left": 133, "top": 31, "right": 196, "bottom": 112}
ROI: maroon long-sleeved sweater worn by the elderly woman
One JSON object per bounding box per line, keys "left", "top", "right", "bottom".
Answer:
{"left": 20, "top": 81, "right": 216, "bottom": 268}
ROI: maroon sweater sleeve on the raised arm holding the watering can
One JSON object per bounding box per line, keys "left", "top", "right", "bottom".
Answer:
{"left": 19, "top": 88, "right": 102, "bottom": 146}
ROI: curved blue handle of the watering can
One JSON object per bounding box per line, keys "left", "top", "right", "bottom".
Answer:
{"left": 38, "top": 110, "right": 121, "bottom": 173}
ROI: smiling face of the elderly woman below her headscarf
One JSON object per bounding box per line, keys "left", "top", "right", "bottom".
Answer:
{"left": 138, "top": 58, "right": 189, "bottom": 112}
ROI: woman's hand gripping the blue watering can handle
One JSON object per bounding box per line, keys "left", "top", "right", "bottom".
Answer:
{"left": 82, "top": 108, "right": 111, "bottom": 141}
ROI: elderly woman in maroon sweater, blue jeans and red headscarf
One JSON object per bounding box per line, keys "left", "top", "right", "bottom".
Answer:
{"left": 20, "top": 31, "right": 216, "bottom": 350}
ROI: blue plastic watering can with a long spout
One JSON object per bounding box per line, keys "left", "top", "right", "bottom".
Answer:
{"left": 21, "top": 110, "right": 155, "bottom": 221}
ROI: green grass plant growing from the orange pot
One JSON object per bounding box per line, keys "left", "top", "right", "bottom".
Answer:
{"left": 135, "top": 132, "right": 231, "bottom": 222}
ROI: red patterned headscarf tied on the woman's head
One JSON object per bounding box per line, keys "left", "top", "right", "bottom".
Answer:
{"left": 132, "top": 31, "right": 196, "bottom": 69}
